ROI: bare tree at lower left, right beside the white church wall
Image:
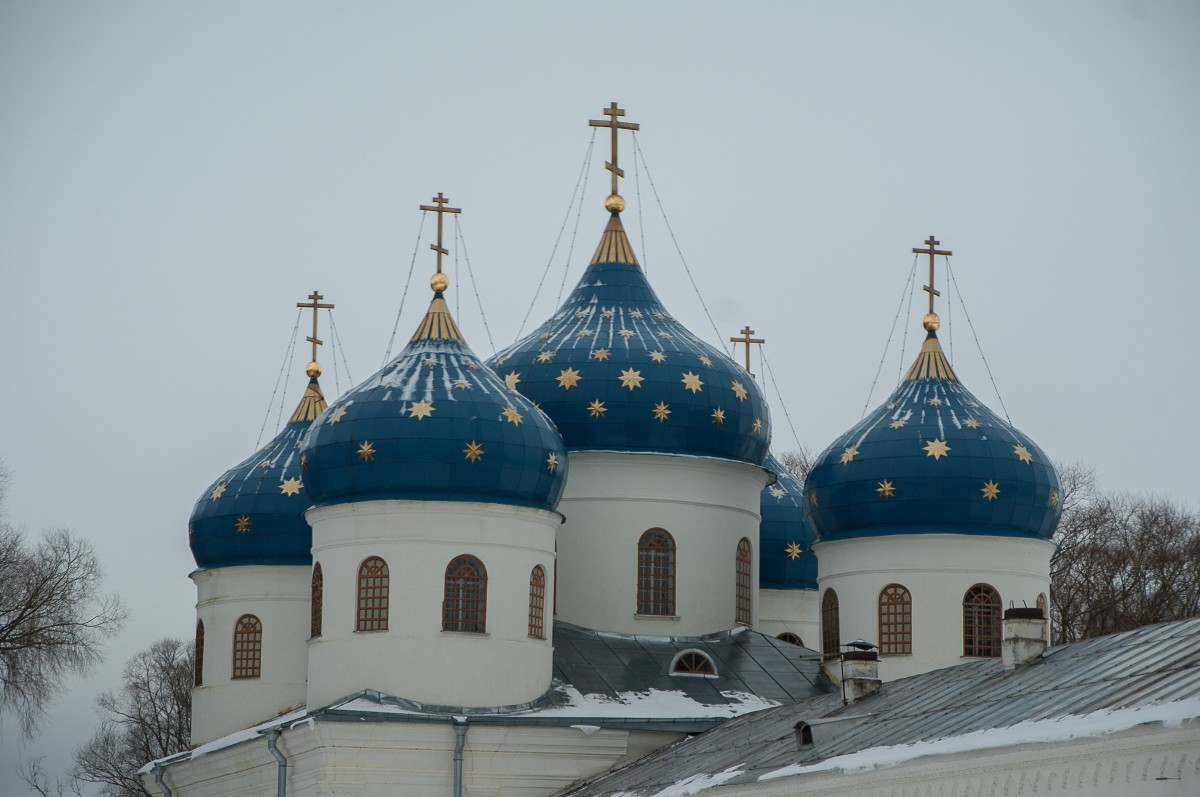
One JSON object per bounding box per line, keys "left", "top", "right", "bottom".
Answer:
{"left": 74, "top": 639, "right": 196, "bottom": 797}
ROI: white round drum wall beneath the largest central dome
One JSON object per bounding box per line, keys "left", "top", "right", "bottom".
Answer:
{"left": 557, "top": 451, "right": 767, "bottom": 636}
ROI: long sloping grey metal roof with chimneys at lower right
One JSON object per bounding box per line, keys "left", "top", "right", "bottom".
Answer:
{"left": 560, "top": 618, "right": 1200, "bottom": 797}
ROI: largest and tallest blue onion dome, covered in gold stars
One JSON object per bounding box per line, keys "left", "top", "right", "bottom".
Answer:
{"left": 488, "top": 208, "right": 770, "bottom": 465}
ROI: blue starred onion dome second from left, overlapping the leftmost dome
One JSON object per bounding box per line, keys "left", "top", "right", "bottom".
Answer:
{"left": 301, "top": 283, "right": 566, "bottom": 510}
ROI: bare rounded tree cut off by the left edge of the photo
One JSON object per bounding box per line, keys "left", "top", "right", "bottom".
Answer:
{"left": 0, "top": 525, "right": 125, "bottom": 735}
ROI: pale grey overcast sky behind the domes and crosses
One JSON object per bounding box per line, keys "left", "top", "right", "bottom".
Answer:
{"left": 0, "top": 1, "right": 1200, "bottom": 795}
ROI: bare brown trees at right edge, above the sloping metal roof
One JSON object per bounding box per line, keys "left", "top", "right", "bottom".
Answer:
{"left": 1050, "top": 465, "right": 1200, "bottom": 643}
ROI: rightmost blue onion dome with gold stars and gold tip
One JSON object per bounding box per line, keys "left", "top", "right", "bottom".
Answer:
{"left": 805, "top": 312, "right": 1062, "bottom": 540}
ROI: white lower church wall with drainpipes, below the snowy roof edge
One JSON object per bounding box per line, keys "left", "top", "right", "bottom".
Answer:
{"left": 143, "top": 718, "right": 680, "bottom": 797}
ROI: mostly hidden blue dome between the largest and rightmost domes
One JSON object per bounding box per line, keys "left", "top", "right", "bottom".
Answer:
{"left": 758, "top": 455, "right": 817, "bottom": 589}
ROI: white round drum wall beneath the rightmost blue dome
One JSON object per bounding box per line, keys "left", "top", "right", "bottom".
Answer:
{"left": 805, "top": 534, "right": 1055, "bottom": 681}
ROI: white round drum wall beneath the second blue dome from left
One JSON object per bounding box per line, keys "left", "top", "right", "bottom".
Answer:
{"left": 306, "top": 501, "right": 562, "bottom": 708}
